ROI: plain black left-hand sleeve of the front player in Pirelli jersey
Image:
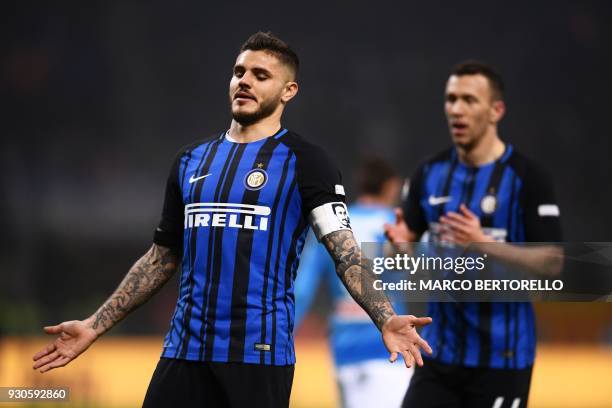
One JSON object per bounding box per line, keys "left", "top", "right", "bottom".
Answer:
{"left": 153, "top": 153, "right": 184, "bottom": 253}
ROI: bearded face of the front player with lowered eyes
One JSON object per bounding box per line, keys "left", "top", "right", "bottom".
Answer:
{"left": 229, "top": 50, "right": 297, "bottom": 125}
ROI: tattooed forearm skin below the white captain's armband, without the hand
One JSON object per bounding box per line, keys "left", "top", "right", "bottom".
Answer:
{"left": 321, "top": 230, "right": 395, "bottom": 330}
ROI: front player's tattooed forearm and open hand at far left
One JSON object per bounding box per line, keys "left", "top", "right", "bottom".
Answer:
{"left": 33, "top": 244, "right": 178, "bottom": 373}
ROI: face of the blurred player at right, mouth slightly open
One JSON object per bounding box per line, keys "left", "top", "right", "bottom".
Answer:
{"left": 444, "top": 74, "right": 503, "bottom": 149}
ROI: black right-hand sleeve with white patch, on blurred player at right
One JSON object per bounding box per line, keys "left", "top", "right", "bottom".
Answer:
{"left": 521, "top": 163, "right": 563, "bottom": 242}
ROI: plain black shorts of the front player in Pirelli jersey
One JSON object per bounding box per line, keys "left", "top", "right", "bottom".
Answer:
{"left": 143, "top": 358, "right": 294, "bottom": 408}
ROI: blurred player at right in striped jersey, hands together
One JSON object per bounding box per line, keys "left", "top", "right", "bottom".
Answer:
{"left": 386, "top": 62, "right": 561, "bottom": 408}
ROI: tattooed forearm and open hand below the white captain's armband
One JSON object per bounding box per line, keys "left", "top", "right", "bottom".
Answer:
{"left": 321, "top": 230, "right": 432, "bottom": 367}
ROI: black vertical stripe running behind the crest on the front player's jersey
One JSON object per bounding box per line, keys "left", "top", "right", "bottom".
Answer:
{"left": 227, "top": 137, "right": 280, "bottom": 361}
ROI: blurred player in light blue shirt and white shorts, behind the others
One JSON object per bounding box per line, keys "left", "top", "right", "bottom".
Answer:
{"left": 295, "top": 158, "right": 414, "bottom": 408}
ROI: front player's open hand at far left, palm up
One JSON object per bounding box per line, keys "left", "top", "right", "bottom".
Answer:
{"left": 32, "top": 320, "right": 98, "bottom": 373}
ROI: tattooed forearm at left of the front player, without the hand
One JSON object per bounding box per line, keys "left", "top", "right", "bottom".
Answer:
{"left": 91, "top": 244, "right": 178, "bottom": 335}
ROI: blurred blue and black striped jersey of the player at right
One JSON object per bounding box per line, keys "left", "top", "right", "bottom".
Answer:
{"left": 404, "top": 145, "right": 561, "bottom": 369}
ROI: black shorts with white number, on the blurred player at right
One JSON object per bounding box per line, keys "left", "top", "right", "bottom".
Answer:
{"left": 402, "top": 359, "right": 532, "bottom": 408}
